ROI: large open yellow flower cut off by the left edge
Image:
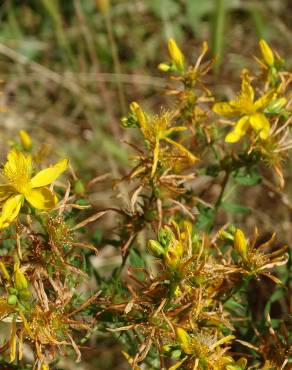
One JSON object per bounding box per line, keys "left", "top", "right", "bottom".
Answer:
{"left": 0, "top": 149, "right": 68, "bottom": 228}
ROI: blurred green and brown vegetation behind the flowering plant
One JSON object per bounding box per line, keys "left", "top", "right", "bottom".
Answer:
{"left": 0, "top": 0, "right": 292, "bottom": 370}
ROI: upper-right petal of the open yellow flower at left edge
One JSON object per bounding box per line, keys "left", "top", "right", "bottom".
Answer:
{"left": 30, "top": 158, "right": 69, "bottom": 188}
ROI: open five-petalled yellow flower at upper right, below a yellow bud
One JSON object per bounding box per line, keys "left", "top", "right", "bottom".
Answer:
{"left": 213, "top": 72, "right": 275, "bottom": 143}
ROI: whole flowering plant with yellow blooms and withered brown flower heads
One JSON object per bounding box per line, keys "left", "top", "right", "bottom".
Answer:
{"left": 0, "top": 39, "right": 292, "bottom": 370}
